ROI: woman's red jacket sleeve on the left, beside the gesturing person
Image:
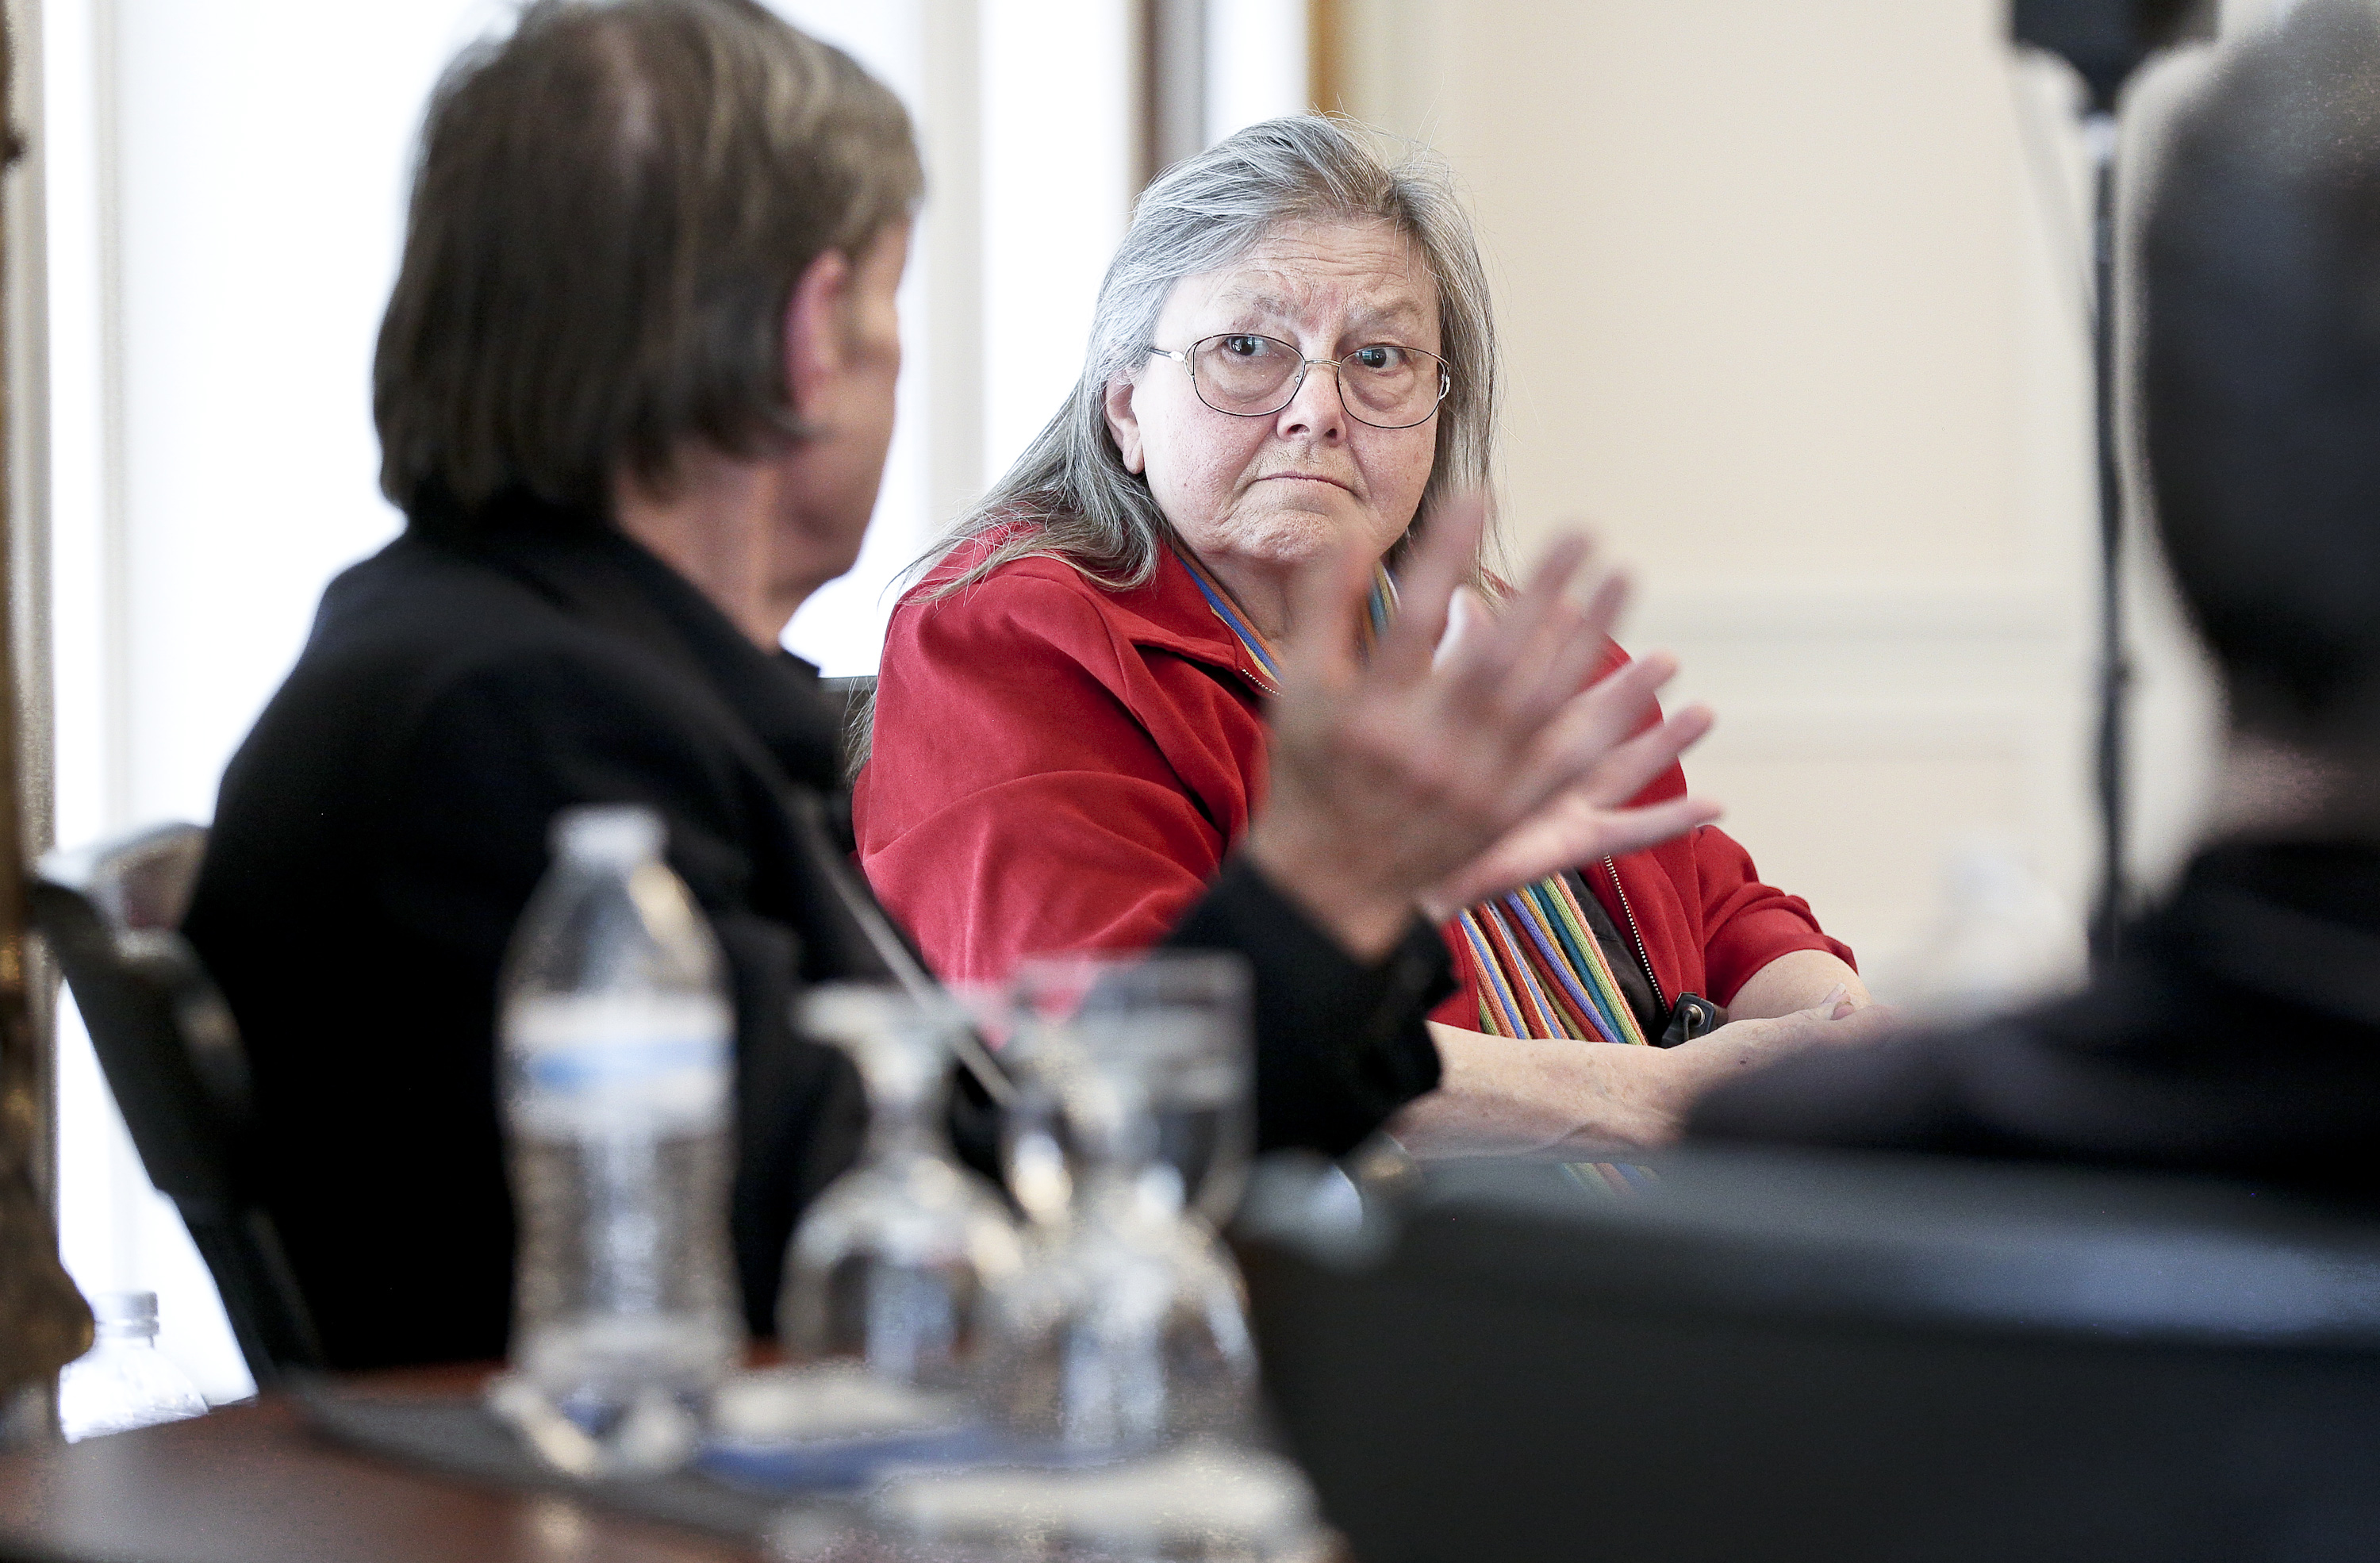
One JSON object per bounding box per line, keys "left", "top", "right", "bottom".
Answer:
{"left": 854, "top": 569, "right": 1254, "bottom": 980}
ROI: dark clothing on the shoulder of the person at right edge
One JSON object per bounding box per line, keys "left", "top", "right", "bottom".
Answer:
{"left": 1690, "top": 842, "right": 2380, "bottom": 1199}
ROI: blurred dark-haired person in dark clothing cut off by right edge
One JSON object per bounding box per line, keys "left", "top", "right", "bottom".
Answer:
{"left": 1692, "top": 0, "right": 2380, "bottom": 1192}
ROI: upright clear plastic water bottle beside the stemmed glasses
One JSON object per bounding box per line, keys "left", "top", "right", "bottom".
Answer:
{"left": 490, "top": 806, "right": 743, "bottom": 1477}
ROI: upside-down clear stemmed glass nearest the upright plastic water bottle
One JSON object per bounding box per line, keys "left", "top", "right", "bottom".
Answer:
{"left": 778, "top": 985, "right": 1021, "bottom": 1389}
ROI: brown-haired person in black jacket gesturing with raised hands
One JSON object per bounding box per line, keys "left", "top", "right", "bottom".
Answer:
{"left": 186, "top": 0, "right": 1702, "bottom": 1368}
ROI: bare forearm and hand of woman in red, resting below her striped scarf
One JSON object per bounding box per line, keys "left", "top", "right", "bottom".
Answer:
{"left": 1388, "top": 987, "right": 1897, "bottom": 1161}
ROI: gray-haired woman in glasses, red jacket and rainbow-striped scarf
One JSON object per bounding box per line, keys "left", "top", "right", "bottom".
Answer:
{"left": 854, "top": 117, "right": 1880, "bottom": 1156}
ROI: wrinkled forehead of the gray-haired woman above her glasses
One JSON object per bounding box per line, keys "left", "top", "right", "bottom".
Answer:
{"left": 1164, "top": 221, "right": 1438, "bottom": 350}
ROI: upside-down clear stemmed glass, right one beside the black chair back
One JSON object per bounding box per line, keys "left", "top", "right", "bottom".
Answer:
{"left": 981, "top": 956, "right": 1257, "bottom": 1456}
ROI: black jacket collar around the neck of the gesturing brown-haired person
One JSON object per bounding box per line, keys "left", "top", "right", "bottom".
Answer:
{"left": 412, "top": 493, "right": 843, "bottom": 792}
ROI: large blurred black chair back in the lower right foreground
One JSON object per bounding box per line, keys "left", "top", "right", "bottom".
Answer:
{"left": 1242, "top": 1151, "right": 2380, "bottom": 1563}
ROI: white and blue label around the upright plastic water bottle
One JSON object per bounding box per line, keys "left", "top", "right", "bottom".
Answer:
{"left": 505, "top": 994, "right": 735, "bottom": 1137}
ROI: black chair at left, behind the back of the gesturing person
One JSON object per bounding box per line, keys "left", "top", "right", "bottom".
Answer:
{"left": 33, "top": 825, "right": 321, "bottom": 1387}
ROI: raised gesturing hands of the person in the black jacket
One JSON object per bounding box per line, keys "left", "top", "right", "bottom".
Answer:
{"left": 1247, "top": 497, "right": 1718, "bottom": 958}
